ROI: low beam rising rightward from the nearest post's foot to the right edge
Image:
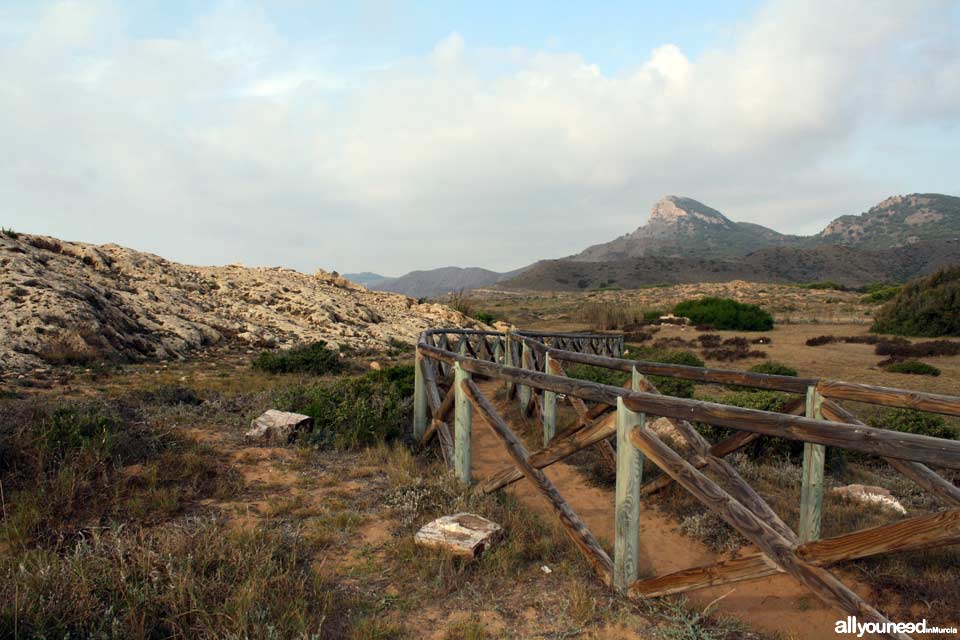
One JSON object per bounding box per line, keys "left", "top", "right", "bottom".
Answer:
{"left": 630, "top": 509, "right": 960, "bottom": 598}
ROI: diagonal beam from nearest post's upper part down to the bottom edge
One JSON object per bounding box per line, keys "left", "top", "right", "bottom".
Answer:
{"left": 630, "top": 429, "right": 909, "bottom": 640}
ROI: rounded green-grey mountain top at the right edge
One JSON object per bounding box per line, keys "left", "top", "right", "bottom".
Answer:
{"left": 815, "top": 193, "right": 960, "bottom": 249}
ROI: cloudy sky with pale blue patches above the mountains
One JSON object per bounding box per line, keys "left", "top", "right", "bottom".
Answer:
{"left": 0, "top": 0, "right": 960, "bottom": 275}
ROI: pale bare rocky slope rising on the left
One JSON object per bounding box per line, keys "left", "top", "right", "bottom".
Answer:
{"left": 0, "top": 232, "right": 474, "bottom": 370}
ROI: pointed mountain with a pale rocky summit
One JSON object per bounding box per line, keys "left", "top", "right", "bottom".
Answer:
{"left": 570, "top": 196, "right": 800, "bottom": 262}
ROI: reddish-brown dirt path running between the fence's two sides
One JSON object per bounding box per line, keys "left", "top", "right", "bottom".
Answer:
{"left": 473, "top": 381, "right": 884, "bottom": 640}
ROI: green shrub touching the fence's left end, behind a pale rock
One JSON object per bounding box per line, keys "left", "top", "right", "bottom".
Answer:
{"left": 279, "top": 365, "right": 413, "bottom": 449}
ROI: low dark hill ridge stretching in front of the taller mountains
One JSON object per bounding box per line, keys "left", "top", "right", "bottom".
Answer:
{"left": 499, "top": 240, "right": 960, "bottom": 291}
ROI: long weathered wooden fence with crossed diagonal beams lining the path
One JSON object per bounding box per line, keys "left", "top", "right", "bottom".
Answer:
{"left": 414, "top": 329, "right": 960, "bottom": 638}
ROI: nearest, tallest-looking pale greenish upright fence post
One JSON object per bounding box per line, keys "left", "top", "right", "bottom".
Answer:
{"left": 613, "top": 398, "right": 646, "bottom": 595}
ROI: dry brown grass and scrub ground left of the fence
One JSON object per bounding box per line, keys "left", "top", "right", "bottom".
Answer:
{"left": 0, "top": 344, "right": 759, "bottom": 639}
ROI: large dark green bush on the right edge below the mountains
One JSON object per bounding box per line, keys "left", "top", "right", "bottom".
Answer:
{"left": 870, "top": 266, "right": 960, "bottom": 337}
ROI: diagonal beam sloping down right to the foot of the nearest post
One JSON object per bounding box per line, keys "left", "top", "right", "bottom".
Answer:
{"left": 459, "top": 380, "right": 613, "bottom": 585}
